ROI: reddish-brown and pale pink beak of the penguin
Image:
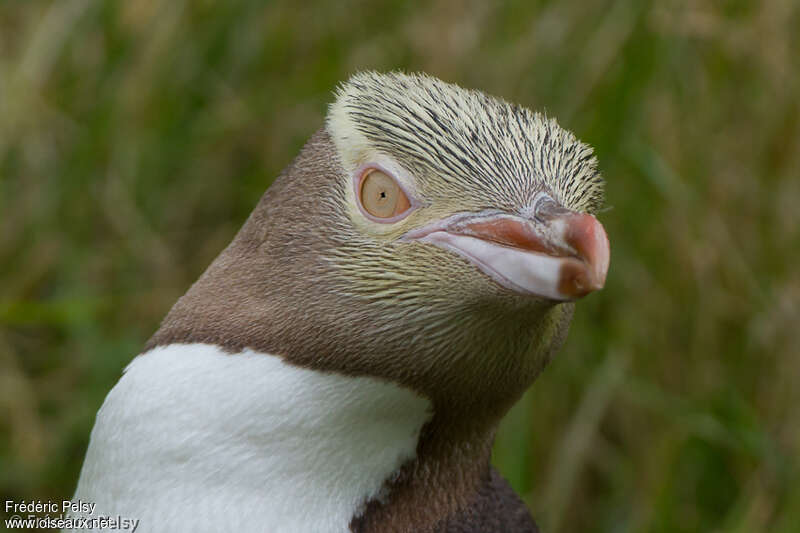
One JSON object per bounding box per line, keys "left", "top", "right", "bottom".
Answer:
{"left": 404, "top": 208, "right": 610, "bottom": 301}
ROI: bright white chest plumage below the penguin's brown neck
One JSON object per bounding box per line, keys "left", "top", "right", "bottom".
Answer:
{"left": 74, "top": 344, "right": 430, "bottom": 532}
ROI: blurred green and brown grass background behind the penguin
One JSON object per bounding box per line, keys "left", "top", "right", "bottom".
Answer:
{"left": 0, "top": 0, "right": 800, "bottom": 533}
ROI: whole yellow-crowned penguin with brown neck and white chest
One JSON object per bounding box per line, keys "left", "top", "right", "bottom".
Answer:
{"left": 73, "top": 72, "right": 609, "bottom": 533}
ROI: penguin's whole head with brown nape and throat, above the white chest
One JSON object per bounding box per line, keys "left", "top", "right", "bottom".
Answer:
{"left": 151, "top": 72, "right": 609, "bottom": 419}
